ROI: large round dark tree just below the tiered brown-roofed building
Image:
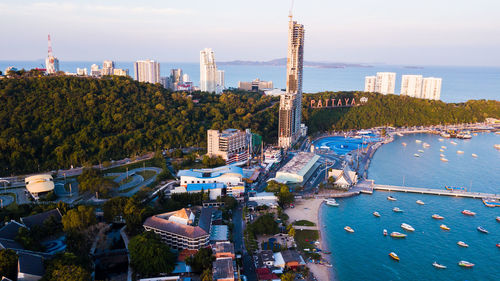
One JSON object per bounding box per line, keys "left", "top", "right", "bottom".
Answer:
{"left": 128, "top": 231, "right": 176, "bottom": 277}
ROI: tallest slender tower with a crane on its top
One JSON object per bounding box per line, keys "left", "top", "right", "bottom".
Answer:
{"left": 278, "top": 14, "right": 305, "bottom": 148}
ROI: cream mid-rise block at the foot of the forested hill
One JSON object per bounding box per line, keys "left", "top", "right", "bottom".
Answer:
{"left": 207, "top": 129, "right": 252, "bottom": 164}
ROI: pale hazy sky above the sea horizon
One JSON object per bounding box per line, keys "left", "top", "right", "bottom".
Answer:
{"left": 0, "top": 0, "right": 500, "bottom": 66}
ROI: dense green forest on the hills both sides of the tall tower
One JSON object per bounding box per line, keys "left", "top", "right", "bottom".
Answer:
{"left": 0, "top": 76, "right": 500, "bottom": 176}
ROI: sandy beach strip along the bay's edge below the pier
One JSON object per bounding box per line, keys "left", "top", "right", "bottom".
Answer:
{"left": 285, "top": 199, "right": 337, "bottom": 281}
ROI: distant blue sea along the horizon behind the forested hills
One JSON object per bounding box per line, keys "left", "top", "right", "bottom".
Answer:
{"left": 0, "top": 60, "right": 500, "bottom": 102}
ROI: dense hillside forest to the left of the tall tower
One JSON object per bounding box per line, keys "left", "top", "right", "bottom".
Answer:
{"left": 0, "top": 74, "right": 278, "bottom": 175}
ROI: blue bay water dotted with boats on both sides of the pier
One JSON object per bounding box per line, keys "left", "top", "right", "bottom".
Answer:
{"left": 320, "top": 133, "right": 500, "bottom": 280}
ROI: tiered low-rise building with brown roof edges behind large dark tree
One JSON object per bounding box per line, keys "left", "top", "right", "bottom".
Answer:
{"left": 143, "top": 208, "right": 213, "bottom": 249}
